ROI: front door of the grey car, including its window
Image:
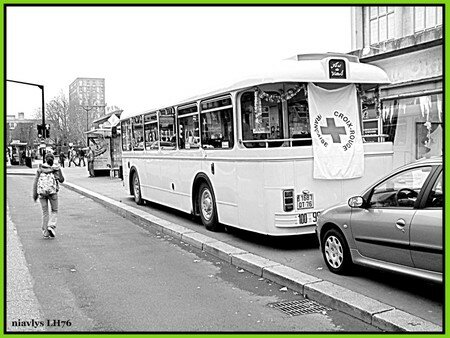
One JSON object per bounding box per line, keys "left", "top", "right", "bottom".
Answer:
{"left": 351, "top": 166, "right": 432, "bottom": 266}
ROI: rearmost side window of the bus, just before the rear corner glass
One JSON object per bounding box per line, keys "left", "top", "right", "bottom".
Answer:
{"left": 200, "top": 97, "right": 234, "bottom": 149}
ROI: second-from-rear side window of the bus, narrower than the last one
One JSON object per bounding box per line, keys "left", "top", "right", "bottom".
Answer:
{"left": 178, "top": 104, "right": 200, "bottom": 149}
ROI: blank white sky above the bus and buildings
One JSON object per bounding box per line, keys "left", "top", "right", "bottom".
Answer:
{"left": 6, "top": 6, "right": 351, "bottom": 118}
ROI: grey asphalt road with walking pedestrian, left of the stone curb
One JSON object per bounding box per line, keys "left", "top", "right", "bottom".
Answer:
{"left": 7, "top": 175, "right": 377, "bottom": 332}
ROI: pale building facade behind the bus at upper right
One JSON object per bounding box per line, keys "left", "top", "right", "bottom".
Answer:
{"left": 350, "top": 6, "right": 444, "bottom": 167}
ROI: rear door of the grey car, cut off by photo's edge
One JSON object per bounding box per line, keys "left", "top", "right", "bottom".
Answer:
{"left": 411, "top": 171, "right": 444, "bottom": 272}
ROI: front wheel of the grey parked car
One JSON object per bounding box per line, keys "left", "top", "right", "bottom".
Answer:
{"left": 321, "top": 229, "right": 352, "bottom": 274}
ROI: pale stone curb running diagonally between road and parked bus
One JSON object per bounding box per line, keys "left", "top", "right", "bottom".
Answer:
{"left": 7, "top": 166, "right": 442, "bottom": 333}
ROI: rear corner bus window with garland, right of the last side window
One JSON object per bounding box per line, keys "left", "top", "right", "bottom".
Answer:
{"left": 241, "top": 90, "right": 283, "bottom": 148}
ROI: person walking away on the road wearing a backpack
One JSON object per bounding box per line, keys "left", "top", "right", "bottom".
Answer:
{"left": 33, "top": 153, "right": 64, "bottom": 238}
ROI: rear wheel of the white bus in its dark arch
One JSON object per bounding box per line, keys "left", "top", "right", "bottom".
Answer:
{"left": 192, "top": 173, "right": 222, "bottom": 231}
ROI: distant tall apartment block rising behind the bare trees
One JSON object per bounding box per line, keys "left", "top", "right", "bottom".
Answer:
{"left": 69, "top": 77, "right": 106, "bottom": 130}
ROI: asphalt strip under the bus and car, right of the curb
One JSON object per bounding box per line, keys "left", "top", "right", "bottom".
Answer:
{"left": 57, "top": 168, "right": 444, "bottom": 325}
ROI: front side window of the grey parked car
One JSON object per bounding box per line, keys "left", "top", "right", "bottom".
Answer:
{"left": 369, "top": 166, "right": 431, "bottom": 209}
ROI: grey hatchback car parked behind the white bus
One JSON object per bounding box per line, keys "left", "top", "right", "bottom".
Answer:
{"left": 316, "top": 157, "right": 444, "bottom": 282}
